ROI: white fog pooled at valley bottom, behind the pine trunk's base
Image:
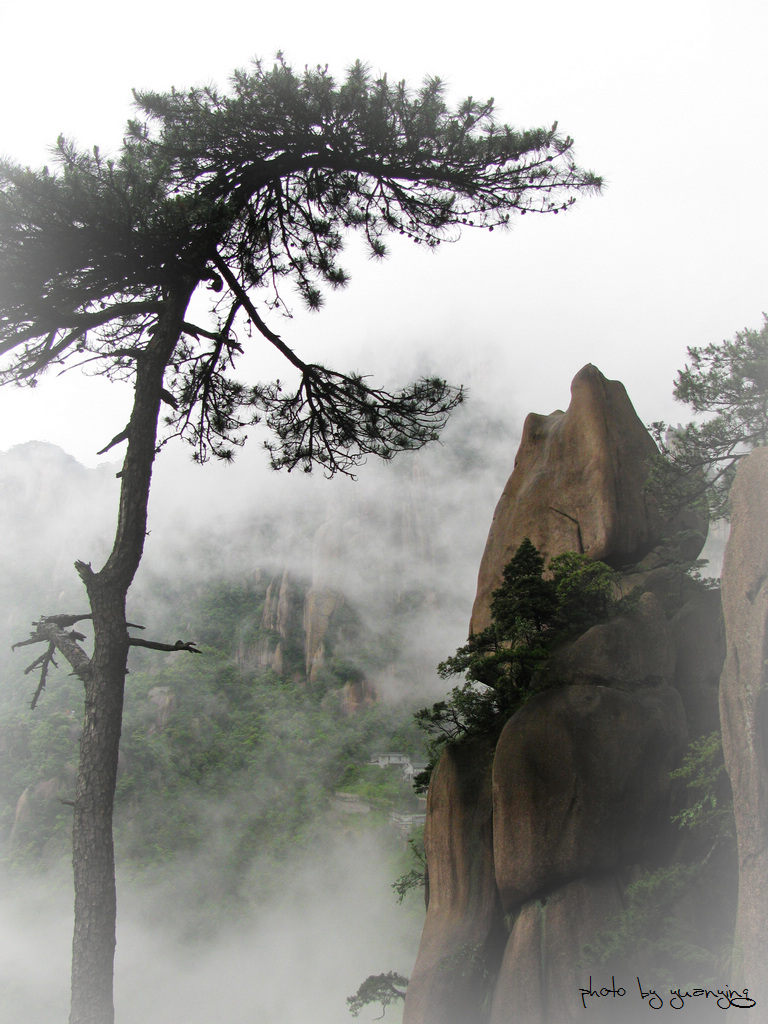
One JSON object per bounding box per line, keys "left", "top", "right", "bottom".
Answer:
{"left": 0, "top": 836, "right": 421, "bottom": 1024}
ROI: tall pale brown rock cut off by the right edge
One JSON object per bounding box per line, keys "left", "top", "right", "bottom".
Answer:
{"left": 720, "top": 449, "right": 768, "bottom": 999}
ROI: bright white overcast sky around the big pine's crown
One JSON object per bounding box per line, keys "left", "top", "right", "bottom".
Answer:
{"left": 0, "top": 0, "right": 768, "bottom": 464}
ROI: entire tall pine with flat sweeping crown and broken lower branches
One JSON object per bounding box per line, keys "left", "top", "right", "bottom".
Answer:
{"left": 0, "top": 57, "right": 600, "bottom": 1024}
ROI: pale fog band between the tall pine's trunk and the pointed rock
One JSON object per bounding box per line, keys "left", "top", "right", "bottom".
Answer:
{"left": 138, "top": 391, "right": 517, "bottom": 696}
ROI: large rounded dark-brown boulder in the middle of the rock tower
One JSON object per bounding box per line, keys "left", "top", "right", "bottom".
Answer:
{"left": 493, "top": 684, "right": 686, "bottom": 912}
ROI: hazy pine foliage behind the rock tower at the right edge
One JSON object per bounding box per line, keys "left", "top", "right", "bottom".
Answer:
{"left": 649, "top": 316, "right": 768, "bottom": 519}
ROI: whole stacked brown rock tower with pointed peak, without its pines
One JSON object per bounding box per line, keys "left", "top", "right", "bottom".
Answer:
{"left": 403, "top": 366, "right": 725, "bottom": 1024}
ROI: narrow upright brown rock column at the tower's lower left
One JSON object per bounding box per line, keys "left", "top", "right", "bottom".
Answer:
{"left": 402, "top": 739, "right": 505, "bottom": 1024}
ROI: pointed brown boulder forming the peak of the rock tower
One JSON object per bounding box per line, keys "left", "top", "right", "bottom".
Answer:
{"left": 470, "top": 364, "right": 707, "bottom": 633}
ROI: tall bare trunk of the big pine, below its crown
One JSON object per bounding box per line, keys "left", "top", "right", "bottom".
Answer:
{"left": 70, "top": 285, "right": 194, "bottom": 1024}
